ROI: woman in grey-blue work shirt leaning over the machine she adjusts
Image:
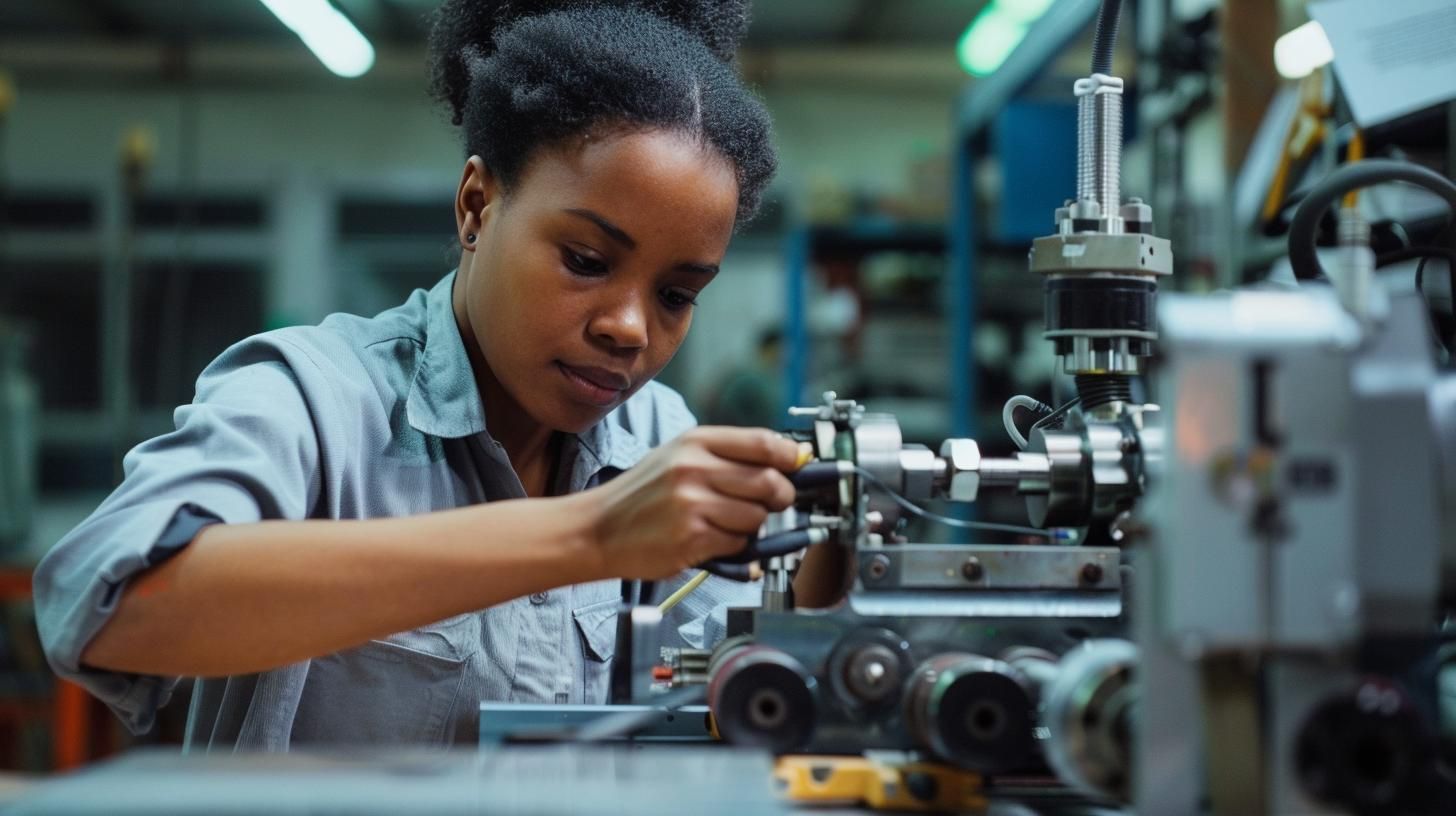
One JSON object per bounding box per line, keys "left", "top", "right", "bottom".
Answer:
{"left": 35, "top": 0, "right": 832, "bottom": 749}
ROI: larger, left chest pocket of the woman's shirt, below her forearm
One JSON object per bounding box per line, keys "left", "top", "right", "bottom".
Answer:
{"left": 291, "top": 613, "right": 480, "bottom": 745}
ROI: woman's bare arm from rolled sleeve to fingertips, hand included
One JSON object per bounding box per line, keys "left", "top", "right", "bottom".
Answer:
{"left": 82, "top": 428, "right": 798, "bottom": 676}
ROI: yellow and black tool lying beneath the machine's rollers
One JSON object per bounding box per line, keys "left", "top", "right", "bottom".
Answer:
{"left": 773, "top": 756, "right": 986, "bottom": 813}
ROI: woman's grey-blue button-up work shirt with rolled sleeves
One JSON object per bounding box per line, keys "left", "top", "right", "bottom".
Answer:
{"left": 35, "top": 274, "right": 759, "bottom": 750}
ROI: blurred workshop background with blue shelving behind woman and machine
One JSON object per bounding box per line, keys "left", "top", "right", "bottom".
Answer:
{"left": 0, "top": 0, "right": 1449, "bottom": 771}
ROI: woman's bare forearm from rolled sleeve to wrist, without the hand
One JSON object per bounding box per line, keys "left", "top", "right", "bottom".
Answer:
{"left": 82, "top": 494, "right": 609, "bottom": 676}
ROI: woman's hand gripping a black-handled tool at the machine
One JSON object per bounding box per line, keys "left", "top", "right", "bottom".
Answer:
{"left": 575, "top": 427, "right": 799, "bottom": 580}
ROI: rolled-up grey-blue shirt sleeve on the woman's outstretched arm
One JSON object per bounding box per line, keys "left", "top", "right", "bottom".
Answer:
{"left": 35, "top": 335, "right": 326, "bottom": 733}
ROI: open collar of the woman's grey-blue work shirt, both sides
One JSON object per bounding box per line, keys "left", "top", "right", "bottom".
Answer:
{"left": 405, "top": 272, "right": 648, "bottom": 471}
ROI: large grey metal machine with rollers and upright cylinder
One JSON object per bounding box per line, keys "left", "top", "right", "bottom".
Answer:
{"left": 635, "top": 4, "right": 1456, "bottom": 815}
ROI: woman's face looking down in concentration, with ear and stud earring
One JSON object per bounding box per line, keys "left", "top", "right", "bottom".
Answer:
{"left": 454, "top": 131, "right": 738, "bottom": 433}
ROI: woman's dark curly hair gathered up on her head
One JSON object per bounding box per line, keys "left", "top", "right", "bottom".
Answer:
{"left": 430, "top": 0, "right": 778, "bottom": 224}
